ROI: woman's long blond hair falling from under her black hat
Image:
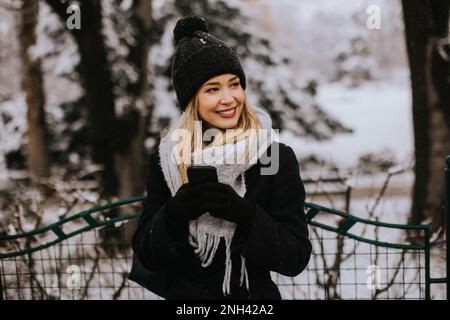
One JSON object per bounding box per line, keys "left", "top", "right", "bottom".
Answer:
{"left": 162, "top": 95, "right": 261, "bottom": 184}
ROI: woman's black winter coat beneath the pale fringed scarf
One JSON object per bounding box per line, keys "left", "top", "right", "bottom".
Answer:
{"left": 133, "top": 143, "right": 311, "bottom": 299}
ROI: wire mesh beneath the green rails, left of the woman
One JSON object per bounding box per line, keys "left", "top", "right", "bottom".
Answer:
{"left": 0, "top": 226, "right": 156, "bottom": 300}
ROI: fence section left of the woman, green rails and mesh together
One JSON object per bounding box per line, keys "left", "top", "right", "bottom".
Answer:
{"left": 0, "top": 198, "right": 155, "bottom": 300}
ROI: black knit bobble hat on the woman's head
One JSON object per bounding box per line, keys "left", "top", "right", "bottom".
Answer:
{"left": 172, "top": 16, "right": 245, "bottom": 110}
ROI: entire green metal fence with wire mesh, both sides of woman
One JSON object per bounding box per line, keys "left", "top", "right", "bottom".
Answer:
{"left": 0, "top": 157, "right": 450, "bottom": 300}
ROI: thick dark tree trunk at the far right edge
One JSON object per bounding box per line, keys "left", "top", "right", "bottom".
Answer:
{"left": 402, "top": 0, "right": 450, "bottom": 232}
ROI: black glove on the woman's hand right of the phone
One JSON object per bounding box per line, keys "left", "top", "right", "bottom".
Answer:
{"left": 202, "top": 183, "right": 256, "bottom": 224}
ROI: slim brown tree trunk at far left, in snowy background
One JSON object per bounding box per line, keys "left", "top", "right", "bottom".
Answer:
{"left": 18, "top": 0, "right": 50, "bottom": 178}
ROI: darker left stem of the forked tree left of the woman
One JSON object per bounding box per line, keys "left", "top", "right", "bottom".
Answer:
{"left": 47, "top": 0, "right": 118, "bottom": 195}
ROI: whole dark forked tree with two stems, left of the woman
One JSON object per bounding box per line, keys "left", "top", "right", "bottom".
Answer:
{"left": 47, "top": 0, "right": 154, "bottom": 198}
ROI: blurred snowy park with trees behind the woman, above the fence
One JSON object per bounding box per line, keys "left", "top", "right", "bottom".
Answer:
{"left": 0, "top": 0, "right": 450, "bottom": 300}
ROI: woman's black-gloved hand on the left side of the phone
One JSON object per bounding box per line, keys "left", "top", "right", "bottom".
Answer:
{"left": 166, "top": 183, "right": 206, "bottom": 223}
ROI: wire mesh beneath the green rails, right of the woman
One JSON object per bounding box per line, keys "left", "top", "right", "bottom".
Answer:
{"left": 273, "top": 227, "right": 427, "bottom": 300}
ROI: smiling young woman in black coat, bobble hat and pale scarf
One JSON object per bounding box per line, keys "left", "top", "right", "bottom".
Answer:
{"left": 133, "top": 16, "right": 311, "bottom": 299}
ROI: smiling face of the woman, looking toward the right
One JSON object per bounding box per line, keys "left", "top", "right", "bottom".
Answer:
{"left": 198, "top": 73, "right": 245, "bottom": 129}
